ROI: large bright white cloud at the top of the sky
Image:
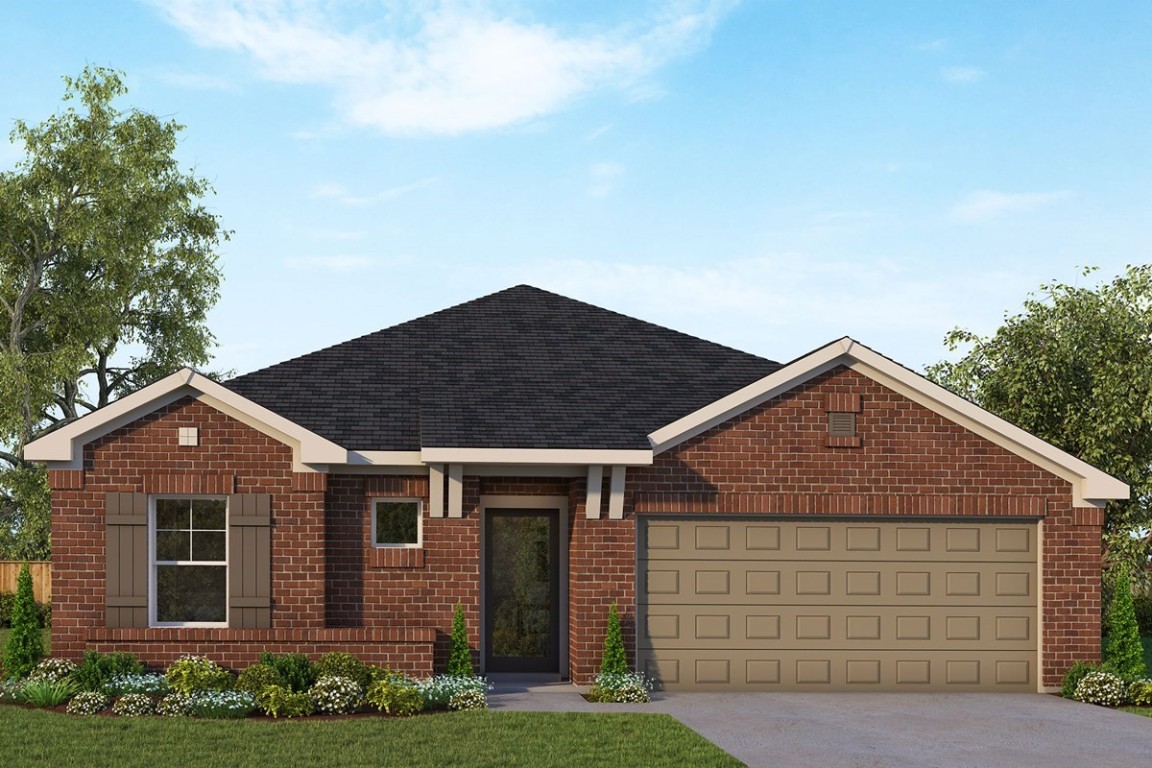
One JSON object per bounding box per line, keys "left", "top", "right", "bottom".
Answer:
{"left": 153, "top": 0, "right": 735, "bottom": 135}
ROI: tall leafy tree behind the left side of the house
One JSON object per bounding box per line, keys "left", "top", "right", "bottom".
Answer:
{"left": 0, "top": 67, "right": 227, "bottom": 558}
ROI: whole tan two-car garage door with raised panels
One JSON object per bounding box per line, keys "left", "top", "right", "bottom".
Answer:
{"left": 637, "top": 518, "right": 1037, "bottom": 691}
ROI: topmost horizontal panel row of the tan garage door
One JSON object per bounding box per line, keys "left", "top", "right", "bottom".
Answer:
{"left": 641, "top": 518, "right": 1036, "bottom": 562}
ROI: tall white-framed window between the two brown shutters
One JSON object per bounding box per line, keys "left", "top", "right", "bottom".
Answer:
{"left": 149, "top": 496, "right": 228, "bottom": 626}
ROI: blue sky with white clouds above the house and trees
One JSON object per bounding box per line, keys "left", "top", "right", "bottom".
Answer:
{"left": 0, "top": 0, "right": 1152, "bottom": 372}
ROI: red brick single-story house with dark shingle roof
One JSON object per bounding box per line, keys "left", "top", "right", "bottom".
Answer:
{"left": 25, "top": 286, "right": 1128, "bottom": 691}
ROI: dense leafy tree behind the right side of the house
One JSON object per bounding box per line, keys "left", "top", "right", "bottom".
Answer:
{"left": 927, "top": 265, "right": 1152, "bottom": 567}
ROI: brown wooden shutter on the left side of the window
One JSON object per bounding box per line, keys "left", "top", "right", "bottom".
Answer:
{"left": 104, "top": 493, "right": 147, "bottom": 629}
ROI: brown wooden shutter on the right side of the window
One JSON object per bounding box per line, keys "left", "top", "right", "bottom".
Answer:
{"left": 228, "top": 493, "right": 272, "bottom": 629}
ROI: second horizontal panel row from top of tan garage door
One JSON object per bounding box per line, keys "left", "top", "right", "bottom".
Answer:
{"left": 639, "top": 560, "right": 1036, "bottom": 606}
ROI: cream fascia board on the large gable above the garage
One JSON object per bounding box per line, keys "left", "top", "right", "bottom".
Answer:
{"left": 649, "top": 336, "right": 1130, "bottom": 507}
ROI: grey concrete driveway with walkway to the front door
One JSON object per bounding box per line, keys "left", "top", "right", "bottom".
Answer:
{"left": 490, "top": 686, "right": 1152, "bottom": 768}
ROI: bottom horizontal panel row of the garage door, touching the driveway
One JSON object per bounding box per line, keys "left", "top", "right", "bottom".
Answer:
{"left": 642, "top": 649, "right": 1036, "bottom": 693}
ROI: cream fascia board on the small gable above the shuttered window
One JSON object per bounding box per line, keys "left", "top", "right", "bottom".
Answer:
{"left": 24, "top": 368, "right": 348, "bottom": 466}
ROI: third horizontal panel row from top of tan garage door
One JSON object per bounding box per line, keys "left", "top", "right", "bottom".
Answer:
{"left": 637, "top": 604, "right": 1037, "bottom": 651}
